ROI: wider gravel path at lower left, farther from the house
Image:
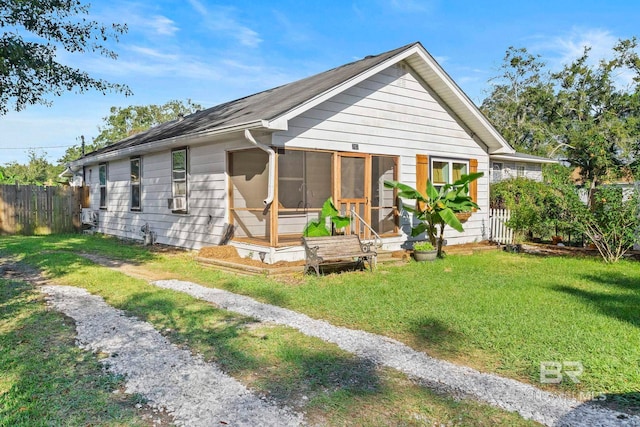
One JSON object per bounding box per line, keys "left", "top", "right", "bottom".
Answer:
{"left": 41, "top": 285, "right": 303, "bottom": 427}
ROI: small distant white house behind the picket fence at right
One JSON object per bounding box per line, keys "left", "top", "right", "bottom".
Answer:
{"left": 489, "top": 153, "right": 558, "bottom": 183}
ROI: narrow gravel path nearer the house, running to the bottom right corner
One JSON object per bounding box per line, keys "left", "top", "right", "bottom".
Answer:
{"left": 153, "top": 280, "right": 640, "bottom": 426}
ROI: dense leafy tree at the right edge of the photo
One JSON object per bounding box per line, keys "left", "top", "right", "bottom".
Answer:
{"left": 552, "top": 38, "right": 640, "bottom": 200}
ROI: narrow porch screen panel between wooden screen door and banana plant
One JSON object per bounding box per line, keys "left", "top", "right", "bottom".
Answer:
{"left": 371, "top": 156, "right": 396, "bottom": 234}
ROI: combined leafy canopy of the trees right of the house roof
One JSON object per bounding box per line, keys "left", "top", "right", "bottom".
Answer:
{"left": 481, "top": 38, "right": 640, "bottom": 187}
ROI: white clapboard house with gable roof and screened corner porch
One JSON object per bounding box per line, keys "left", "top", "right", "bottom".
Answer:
{"left": 70, "top": 43, "right": 552, "bottom": 262}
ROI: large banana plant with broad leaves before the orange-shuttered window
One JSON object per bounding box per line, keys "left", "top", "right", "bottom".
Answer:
{"left": 384, "top": 172, "right": 484, "bottom": 258}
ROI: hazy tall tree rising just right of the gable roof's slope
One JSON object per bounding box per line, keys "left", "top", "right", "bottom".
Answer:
{"left": 480, "top": 46, "right": 555, "bottom": 155}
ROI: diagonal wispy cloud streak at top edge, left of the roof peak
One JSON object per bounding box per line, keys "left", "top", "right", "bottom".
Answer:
{"left": 189, "top": 0, "right": 262, "bottom": 47}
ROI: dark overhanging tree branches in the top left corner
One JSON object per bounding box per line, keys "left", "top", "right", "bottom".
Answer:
{"left": 0, "top": 0, "right": 131, "bottom": 115}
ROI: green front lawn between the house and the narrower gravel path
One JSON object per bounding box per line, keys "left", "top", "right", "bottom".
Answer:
{"left": 0, "top": 236, "right": 640, "bottom": 410}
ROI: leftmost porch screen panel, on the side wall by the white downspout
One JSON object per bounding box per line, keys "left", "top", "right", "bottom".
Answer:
{"left": 229, "top": 148, "right": 270, "bottom": 240}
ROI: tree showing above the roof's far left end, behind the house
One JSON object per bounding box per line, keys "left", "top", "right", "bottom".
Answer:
{"left": 59, "top": 99, "right": 203, "bottom": 163}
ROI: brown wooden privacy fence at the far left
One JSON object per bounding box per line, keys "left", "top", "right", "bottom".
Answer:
{"left": 0, "top": 185, "right": 88, "bottom": 236}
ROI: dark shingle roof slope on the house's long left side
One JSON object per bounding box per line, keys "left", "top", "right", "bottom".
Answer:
{"left": 85, "top": 43, "right": 419, "bottom": 158}
